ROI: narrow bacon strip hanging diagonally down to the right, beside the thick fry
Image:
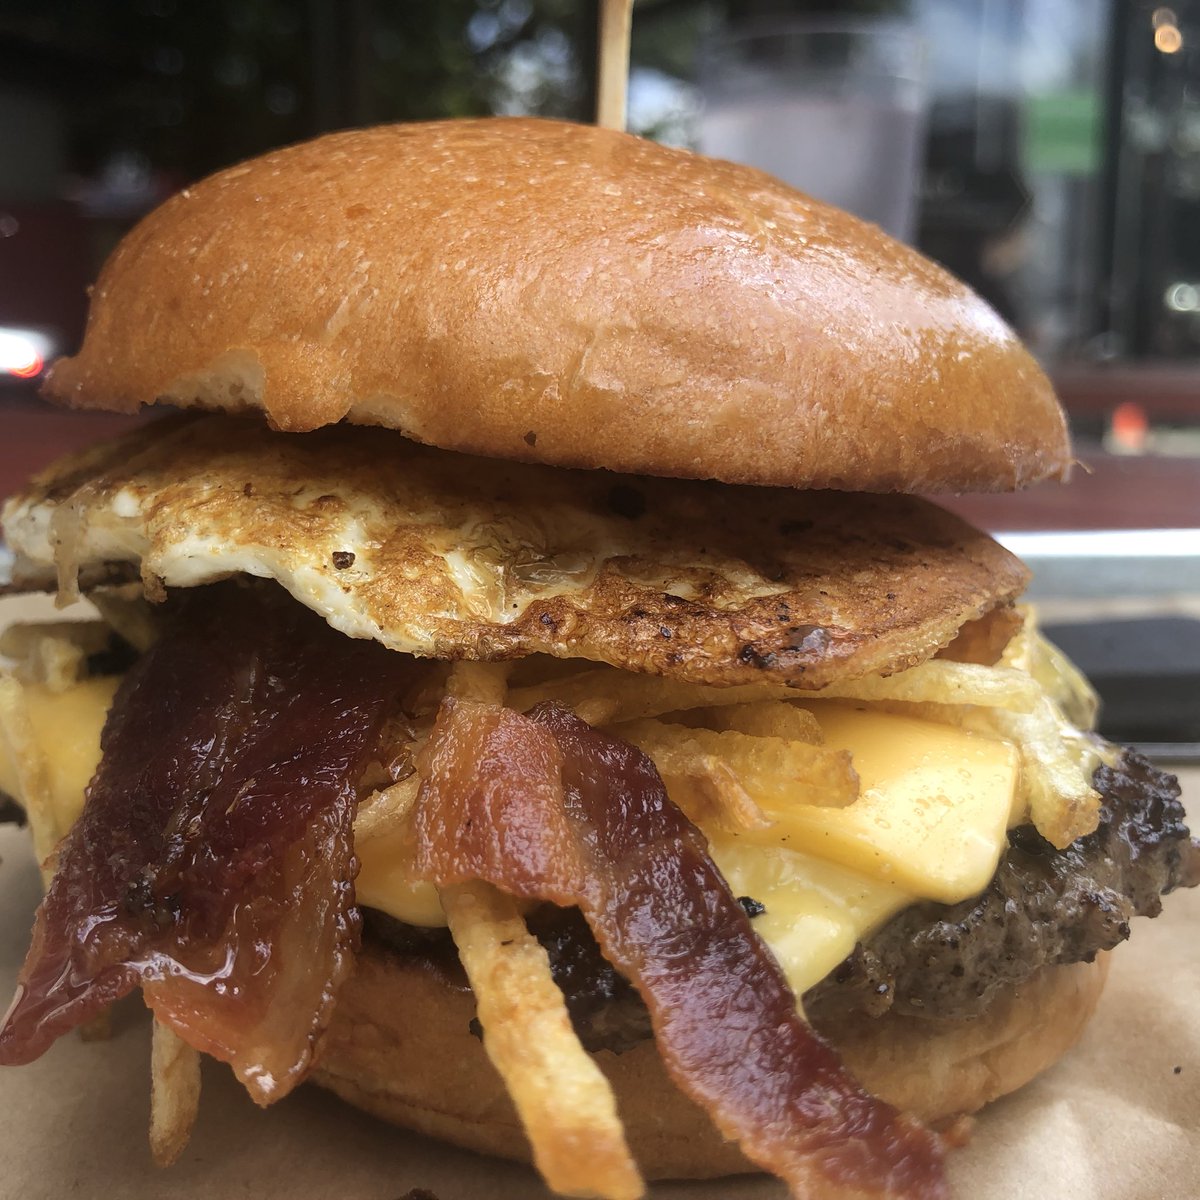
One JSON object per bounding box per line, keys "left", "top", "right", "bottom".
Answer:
{"left": 415, "top": 700, "right": 947, "bottom": 1200}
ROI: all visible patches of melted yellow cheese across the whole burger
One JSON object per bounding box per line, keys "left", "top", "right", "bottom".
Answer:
{"left": 0, "top": 679, "right": 1022, "bottom": 996}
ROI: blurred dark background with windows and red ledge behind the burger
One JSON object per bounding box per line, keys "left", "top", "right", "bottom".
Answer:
{"left": 0, "top": 0, "right": 1200, "bottom": 744}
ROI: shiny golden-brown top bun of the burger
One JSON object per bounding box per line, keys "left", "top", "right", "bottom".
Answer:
{"left": 46, "top": 112, "right": 1070, "bottom": 492}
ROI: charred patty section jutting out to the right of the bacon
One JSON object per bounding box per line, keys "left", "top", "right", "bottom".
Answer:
{"left": 804, "top": 750, "right": 1200, "bottom": 1022}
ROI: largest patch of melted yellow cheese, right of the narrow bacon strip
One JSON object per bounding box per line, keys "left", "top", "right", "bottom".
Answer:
{"left": 709, "top": 703, "right": 1022, "bottom": 996}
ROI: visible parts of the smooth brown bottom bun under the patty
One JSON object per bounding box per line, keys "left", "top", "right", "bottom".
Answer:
{"left": 312, "top": 943, "right": 1108, "bottom": 1178}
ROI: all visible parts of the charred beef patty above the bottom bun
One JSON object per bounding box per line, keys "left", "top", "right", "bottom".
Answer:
{"left": 366, "top": 751, "right": 1200, "bottom": 1054}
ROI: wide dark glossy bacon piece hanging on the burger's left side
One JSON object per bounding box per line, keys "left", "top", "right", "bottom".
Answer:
{"left": 0, "top": 584, "right": 412, "bottom": 1104}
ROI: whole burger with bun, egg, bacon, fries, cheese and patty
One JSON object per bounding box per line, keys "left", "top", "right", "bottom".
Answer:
{"left": 0, "top": 120, "right": 1200, "bottom": 1198}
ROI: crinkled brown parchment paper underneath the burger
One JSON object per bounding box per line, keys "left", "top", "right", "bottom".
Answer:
{"left": 0, "top": 601, "right": 1200, "bottom": 1200}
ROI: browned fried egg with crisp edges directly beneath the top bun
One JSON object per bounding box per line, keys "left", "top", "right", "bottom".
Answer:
{"left": 4, "top": 415, "right": 1027, "bottom": 689}
